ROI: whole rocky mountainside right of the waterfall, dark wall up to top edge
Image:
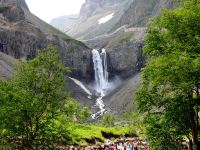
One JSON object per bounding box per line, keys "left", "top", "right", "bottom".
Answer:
{"left": 106, "top": 0, "right": 178, "bottom": 76}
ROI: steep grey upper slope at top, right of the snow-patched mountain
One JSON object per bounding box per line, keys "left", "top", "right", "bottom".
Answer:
{"left": 112, "top": 0, "right": 178, "bottom": 31}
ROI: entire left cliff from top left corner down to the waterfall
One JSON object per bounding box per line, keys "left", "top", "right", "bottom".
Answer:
{"left": 0, "top": 0, "right": 90, "bottom": 79}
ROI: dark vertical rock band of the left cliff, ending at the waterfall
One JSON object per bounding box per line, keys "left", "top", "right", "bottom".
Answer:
{"left": 0, "top": 30, "right": 90, "bottom": 80}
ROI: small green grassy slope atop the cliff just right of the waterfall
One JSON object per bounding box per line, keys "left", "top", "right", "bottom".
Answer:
{"left": 108, "top": 32, "right": 134, "bottom": 48}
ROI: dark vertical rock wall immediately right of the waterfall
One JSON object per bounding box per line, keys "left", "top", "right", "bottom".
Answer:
{"left": 108, "top": 42, "right": 144, "bottom": 79}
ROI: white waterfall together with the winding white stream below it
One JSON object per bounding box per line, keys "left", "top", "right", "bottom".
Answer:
{"left": 92, "top": 49, "right": 109, "bottom": 119}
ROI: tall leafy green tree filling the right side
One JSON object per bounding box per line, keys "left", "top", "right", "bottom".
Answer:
{"left": 136, "top": 0, "right": 200, "bottom": 150}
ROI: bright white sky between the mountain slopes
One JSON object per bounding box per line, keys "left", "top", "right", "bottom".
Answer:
{"left": 25, "top": 0, "right": 85, "bottom": 23}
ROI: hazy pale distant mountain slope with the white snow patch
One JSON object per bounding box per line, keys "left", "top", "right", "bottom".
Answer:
{"left": 51, "top": 0, "right": 134, "bottom": 40}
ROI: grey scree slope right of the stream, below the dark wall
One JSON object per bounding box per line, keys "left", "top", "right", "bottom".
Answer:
{"left": 103, "top": 73, "right": 141, "bottom": 117}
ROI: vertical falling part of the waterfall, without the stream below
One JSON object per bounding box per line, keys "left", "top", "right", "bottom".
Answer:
{"left": 92, "top": 49, "right": 109, "bottom": 95}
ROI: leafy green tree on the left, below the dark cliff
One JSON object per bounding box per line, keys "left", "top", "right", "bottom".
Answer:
{"left": 0, "top": 46, "right": 69, "bottom": 148}
